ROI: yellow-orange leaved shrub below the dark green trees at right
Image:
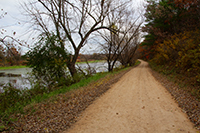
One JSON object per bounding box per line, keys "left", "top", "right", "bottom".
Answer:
{"left": 152, "top": 29, "right": 200, "bottom": 84}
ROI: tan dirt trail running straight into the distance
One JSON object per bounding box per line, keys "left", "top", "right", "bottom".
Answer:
{"left": 65, "top": 61, "right": 198, "bottom": 133}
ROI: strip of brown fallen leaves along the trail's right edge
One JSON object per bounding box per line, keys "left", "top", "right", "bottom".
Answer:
{"left": 151, "top": 70, "right": 200, "bottom": 130}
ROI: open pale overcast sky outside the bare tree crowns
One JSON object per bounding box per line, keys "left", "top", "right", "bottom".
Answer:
{"left": 0, "top": 0, "right": 144, "bottom": 52}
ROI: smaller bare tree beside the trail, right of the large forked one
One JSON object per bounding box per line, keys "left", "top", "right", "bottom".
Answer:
{"left": 99, "top": 8, "right": 143, "bottom": 71}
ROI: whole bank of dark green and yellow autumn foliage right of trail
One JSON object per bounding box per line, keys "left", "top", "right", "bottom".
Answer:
{"left": 139, "top": 0, "right": 200, "bottom": 85}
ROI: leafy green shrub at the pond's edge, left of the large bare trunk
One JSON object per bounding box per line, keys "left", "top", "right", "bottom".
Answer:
{"left": 26, "top": 33, "right": 70, "bottom": 88}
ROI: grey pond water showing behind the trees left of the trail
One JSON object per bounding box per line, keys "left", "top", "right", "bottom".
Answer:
{"left": 0, "top": 61, "right": 120, "bottom": 91}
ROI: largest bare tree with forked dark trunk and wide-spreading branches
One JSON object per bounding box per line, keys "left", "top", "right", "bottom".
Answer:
{"left": 23, "top": 0, "right": 129, "bottom": 76}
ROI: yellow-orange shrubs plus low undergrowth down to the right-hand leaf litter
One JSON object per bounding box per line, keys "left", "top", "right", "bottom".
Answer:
{"left": 150, "top": 29, "right": 200, "bottom": 100}
